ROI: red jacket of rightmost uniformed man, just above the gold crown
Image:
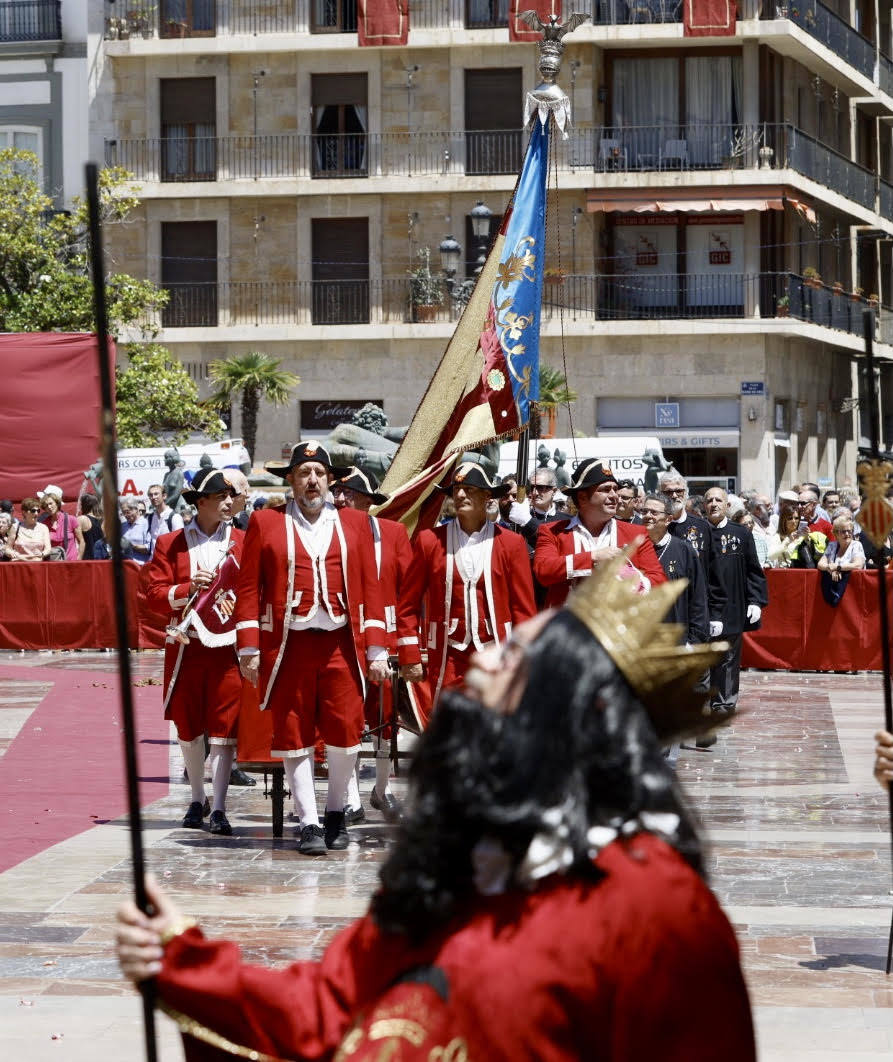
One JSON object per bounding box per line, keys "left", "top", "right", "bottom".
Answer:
{"left": 533, "top": 519, "right": 667, "bottom": 609}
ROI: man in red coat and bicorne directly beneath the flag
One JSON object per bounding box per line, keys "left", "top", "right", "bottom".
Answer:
{"left": 397, "top": 461, "right": 536, "bottom": 704}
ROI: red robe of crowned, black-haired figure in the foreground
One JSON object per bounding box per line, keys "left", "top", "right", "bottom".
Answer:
{"left": 157, "top": 834, "right": 756, "bottom": 1062}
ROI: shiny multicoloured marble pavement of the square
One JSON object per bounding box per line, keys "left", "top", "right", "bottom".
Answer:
{"left": 0, "top": 653, "right": 893, "bottom": 1062}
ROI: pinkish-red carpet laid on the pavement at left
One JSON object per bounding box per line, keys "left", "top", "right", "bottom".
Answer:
{"left": 0, "top": 666, "right": 170, "bottom": 872}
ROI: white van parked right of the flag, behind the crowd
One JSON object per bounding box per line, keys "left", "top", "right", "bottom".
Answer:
{"left": 499, "top": 435, "right": 672, "bottom": 491}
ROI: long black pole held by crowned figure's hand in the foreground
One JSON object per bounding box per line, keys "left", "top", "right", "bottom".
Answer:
{"left": 85, "top": 162, "right": 158, "bottom": 1062}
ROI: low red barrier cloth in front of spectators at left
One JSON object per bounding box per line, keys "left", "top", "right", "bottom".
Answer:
{"left": 0, "top": 561, "right": 165, "bottom": 649}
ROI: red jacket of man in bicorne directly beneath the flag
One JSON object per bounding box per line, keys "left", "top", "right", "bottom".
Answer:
{"left": 397, "top": 524, "right": 536, "bottom": 695}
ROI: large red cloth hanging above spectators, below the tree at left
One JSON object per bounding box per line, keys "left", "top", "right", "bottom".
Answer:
{"left": 0, "top": 332, "right": 115, "bottom": 501}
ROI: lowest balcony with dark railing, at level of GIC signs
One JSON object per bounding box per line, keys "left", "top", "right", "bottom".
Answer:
{"left": 161, "top": 273, "right": 870, "bottom": 336}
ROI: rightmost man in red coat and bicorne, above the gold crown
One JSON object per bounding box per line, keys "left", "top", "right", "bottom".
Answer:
{"left": 533, "top": 459, "right": 667, "bottom": 607}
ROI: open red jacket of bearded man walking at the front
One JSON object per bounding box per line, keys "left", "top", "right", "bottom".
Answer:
{"left": 236, "top": 507, "right": 384, "bottom": 709}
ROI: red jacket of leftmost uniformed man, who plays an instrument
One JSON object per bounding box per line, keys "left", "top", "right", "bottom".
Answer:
{"left": 139, "top": 526, "right": 245, "bottom": 707}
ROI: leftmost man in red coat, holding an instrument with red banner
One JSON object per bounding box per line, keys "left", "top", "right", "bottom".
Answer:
{"left": 140, "top": 468, "right": 244, "bottom": 837}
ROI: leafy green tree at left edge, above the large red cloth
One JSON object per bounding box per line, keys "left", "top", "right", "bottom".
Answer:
{"left": 0, "top": 149, "right": 168, "bottom": 335}
